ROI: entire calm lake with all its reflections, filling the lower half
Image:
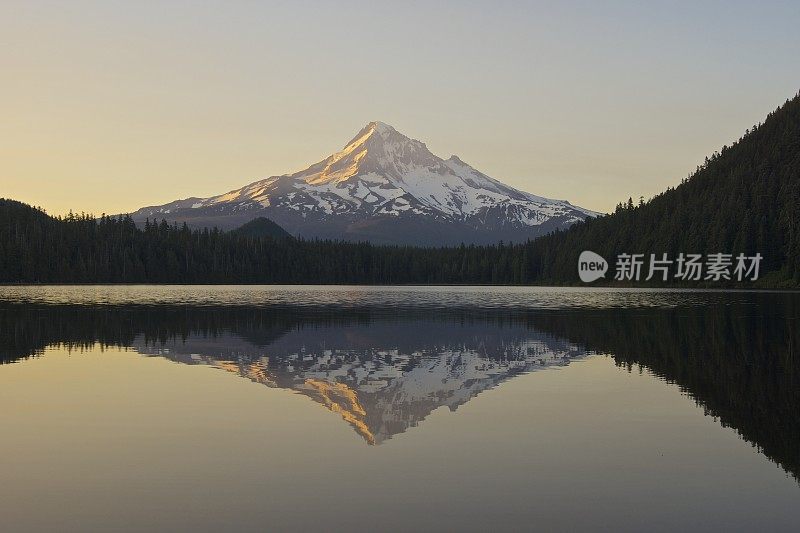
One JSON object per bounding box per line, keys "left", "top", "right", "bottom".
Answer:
{"left": 0, "top": 286, "right": 800, "bottom": 532}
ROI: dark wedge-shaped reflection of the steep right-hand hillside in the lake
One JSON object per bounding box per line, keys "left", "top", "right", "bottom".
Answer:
{"left": 533, "top": 295, "right": 800, "bottom": 479}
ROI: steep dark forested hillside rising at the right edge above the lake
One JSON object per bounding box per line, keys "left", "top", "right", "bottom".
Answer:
{"left": 528, "top": 90, "right": 800, "bottom": 285}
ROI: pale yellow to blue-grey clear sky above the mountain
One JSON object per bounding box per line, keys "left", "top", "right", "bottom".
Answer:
{"left": 0, "top": 0, "right": 800, "bottom": 215}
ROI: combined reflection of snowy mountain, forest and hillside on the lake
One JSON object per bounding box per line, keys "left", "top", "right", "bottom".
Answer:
{"left": 0, "top": 293, "right": 800, "bottom": 478}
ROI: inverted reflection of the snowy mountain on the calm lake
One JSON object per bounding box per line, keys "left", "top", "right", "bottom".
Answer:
{"left": 138, "top": 320, "right": 585, "bottom": 444}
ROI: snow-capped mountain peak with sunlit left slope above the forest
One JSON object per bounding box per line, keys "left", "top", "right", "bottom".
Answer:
{"left": 133, "top": 122, "right": 597, "bottom": 244}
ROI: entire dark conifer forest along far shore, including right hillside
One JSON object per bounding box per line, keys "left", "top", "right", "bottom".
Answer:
{"left": 0, "top": 90, "right": 800, "bottom": 287}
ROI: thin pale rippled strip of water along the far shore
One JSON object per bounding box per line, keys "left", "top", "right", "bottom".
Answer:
{"left": 0, "top": 285, "right": 788, "bottom": 312}
